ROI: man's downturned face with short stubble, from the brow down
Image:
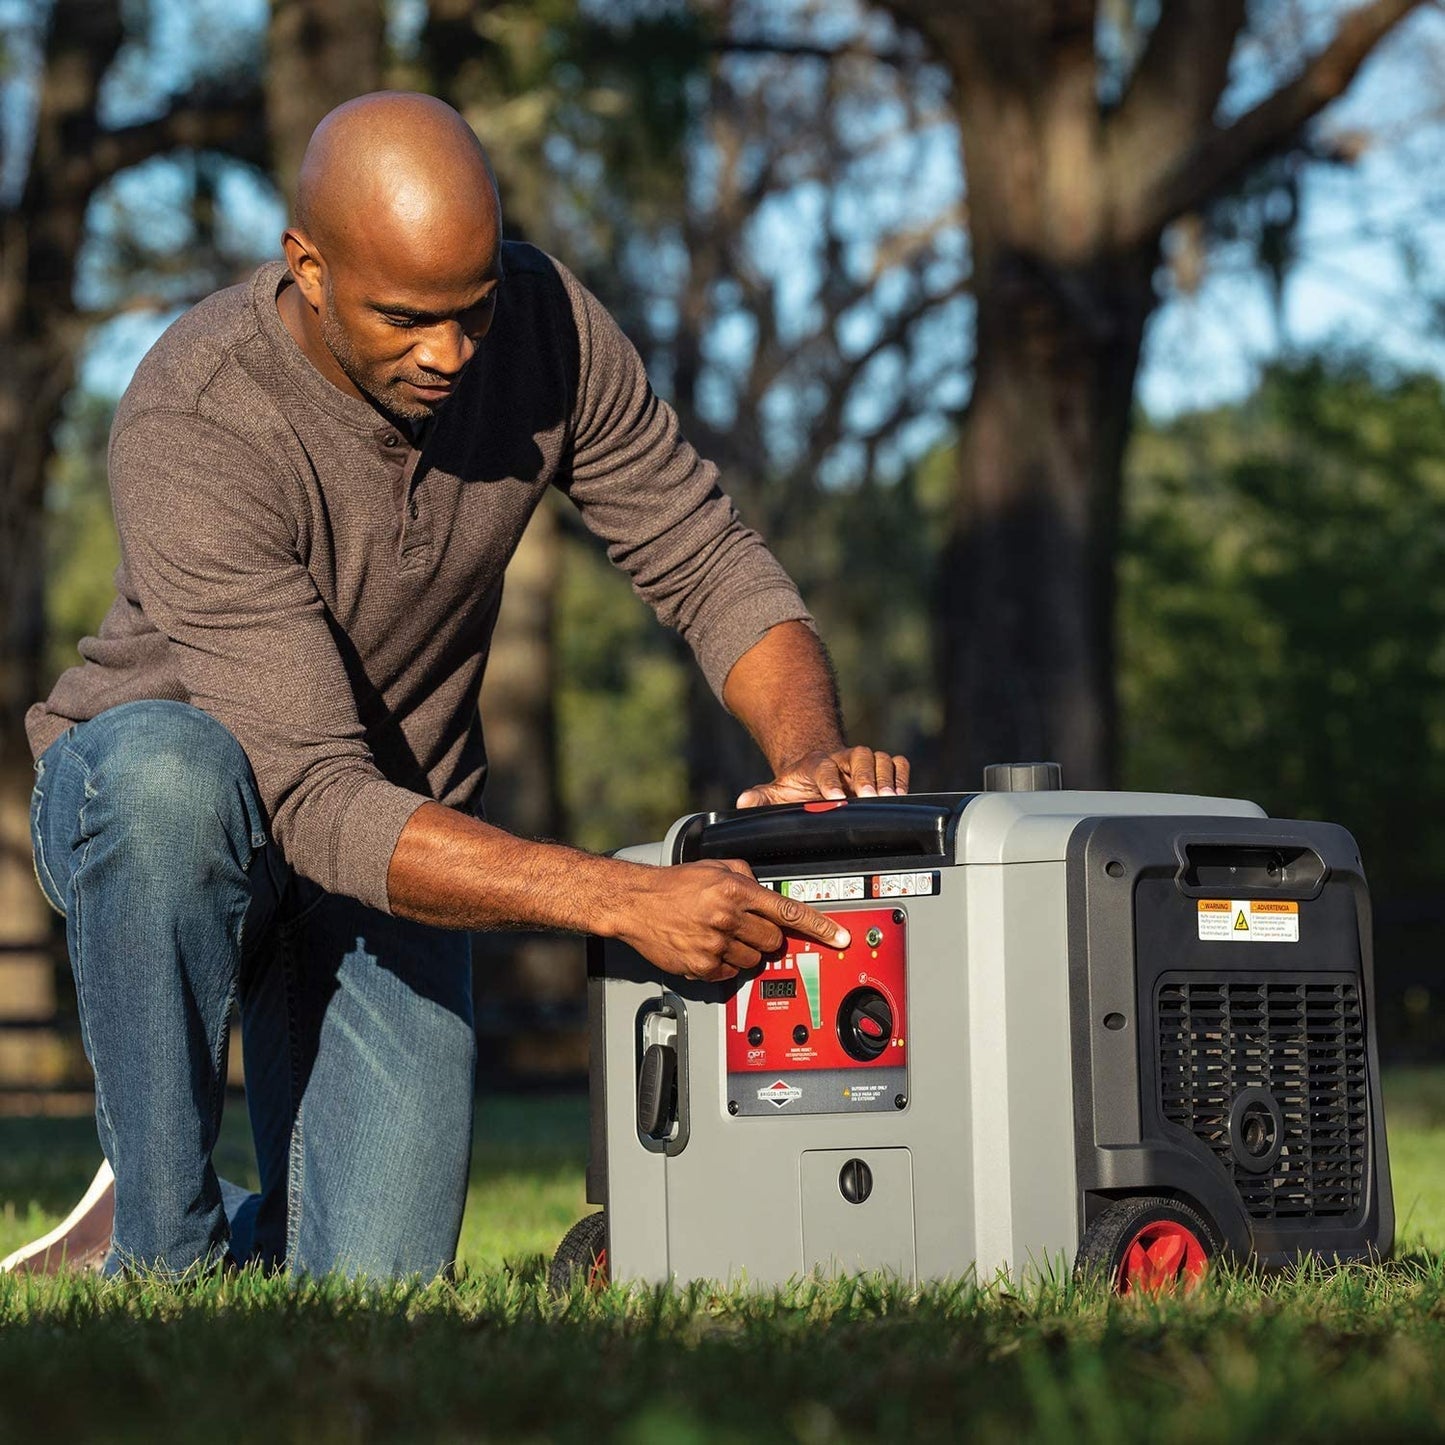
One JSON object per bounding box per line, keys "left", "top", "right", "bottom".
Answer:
{"left": 319, "top": 240, "right": 501, "bottom": 422}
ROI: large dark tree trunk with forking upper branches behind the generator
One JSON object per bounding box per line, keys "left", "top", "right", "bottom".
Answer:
{"left": 881, "top": 0, "right": 1420, "bottom": 788}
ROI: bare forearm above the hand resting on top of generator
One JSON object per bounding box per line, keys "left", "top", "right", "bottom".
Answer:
{"left": 723, "top": 623, "right": 844, "bottom": 773}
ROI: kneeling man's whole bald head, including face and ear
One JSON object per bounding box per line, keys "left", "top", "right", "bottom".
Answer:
{"left": 277, "top": 91, "right": 501, "bottom": 423}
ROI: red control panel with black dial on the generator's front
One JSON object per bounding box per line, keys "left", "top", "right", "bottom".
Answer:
{"left": 727, "top": 907, "right": 907, "bottom": 1074}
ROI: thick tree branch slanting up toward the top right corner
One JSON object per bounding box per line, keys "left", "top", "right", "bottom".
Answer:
{"left": 1126, "top": 0, "right": 1425, "bottom": 243}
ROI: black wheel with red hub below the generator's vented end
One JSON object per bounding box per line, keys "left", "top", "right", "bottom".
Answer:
{"left": 1074, "top": 1195, "right": 1220, "bottom": 1295}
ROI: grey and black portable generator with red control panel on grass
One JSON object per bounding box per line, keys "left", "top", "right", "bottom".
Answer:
{"left": 552, "top": 763, "right": 1394, "bottom": 1290}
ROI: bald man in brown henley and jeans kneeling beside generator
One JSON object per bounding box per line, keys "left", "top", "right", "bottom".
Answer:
{"left": 11, "top": 92, "right": 907, "bottom": 1277}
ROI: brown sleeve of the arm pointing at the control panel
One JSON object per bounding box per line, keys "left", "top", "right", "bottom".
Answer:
{"left": 110, "top": 410, "right": 425, "bottom": 909}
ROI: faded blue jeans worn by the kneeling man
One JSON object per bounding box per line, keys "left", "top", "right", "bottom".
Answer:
{"left": 30, "top": 702, "right": 475, "bottom": 1279}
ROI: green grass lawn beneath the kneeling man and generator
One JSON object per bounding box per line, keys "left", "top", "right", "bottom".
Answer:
{"left": 0, "top": 1071, "right": 1445, "bottom": 1445}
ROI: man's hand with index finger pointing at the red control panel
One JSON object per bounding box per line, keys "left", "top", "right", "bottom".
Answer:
{"left": 617, "top": 858, "right": 848, "bottom": 983}
